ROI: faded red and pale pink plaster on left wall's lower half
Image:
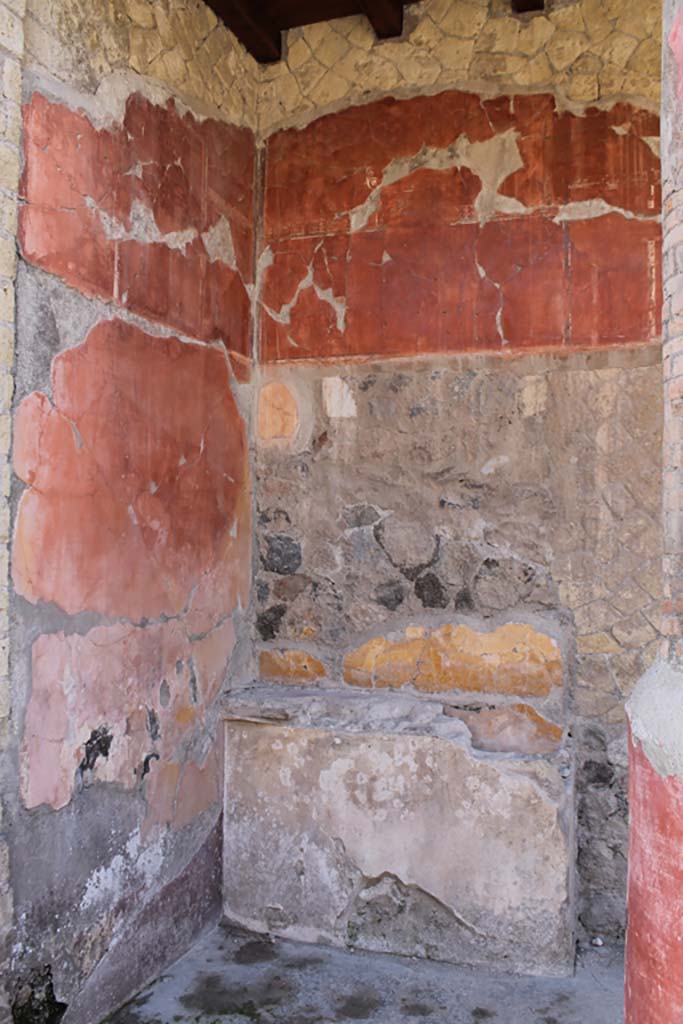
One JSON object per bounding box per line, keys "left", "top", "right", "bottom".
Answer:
{"left": 12, "top": 321, "right": 249, "bottom": 824}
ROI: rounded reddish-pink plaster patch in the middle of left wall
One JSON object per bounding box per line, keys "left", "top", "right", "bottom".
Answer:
{"left": 13, "top": 321, "right": 248, "bottom": 622}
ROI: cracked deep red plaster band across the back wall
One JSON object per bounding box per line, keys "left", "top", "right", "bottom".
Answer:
{"left": 261, "top": 92, "right": 660, "bottom": 361}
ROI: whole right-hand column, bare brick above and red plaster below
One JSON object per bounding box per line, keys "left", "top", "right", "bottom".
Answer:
{"left": 626, "top": 0, "right": 683, "bottom": 1024}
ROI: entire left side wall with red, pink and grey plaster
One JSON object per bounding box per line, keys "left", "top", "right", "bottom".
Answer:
{"left": 0, "top": 0, "right": 256, "bottom": 1022}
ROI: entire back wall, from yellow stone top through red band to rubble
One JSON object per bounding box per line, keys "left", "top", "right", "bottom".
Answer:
{"left": 249, "top": 0, "right": 661, "bottom": 936}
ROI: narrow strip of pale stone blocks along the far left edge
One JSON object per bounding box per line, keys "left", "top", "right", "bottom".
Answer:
{"left": 0, "top": 0, "right": 25, "bottom": 1024}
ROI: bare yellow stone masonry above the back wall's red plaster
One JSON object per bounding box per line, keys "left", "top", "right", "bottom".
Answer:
{"left": 258, "top": 0, "right": 661, "bottom": 135}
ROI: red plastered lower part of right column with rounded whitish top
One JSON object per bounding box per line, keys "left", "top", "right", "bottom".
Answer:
{"left": 626, "top": 662, "right": 683, "bottom": 1024}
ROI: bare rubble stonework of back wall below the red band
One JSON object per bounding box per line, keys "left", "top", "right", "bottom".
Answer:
{"left": 255, "top": 347, "right": 660, "bottom": 934}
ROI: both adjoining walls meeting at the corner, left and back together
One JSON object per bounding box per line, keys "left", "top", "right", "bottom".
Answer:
{"left": 0, "top": 0, "right": 659, "bottom": 1021}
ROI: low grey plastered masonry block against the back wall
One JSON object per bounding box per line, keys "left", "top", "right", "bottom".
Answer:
{"left": 224, "top": 693, "right": 574, "bottom": 974}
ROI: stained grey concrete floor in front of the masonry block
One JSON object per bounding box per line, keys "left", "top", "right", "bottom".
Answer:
{"left": 110, "top": 926, "right": 624, "bottom": 1024}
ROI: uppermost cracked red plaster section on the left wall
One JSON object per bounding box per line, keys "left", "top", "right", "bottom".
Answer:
{"left": 19, "top": 92, "right": 255, "bottom": 356}
